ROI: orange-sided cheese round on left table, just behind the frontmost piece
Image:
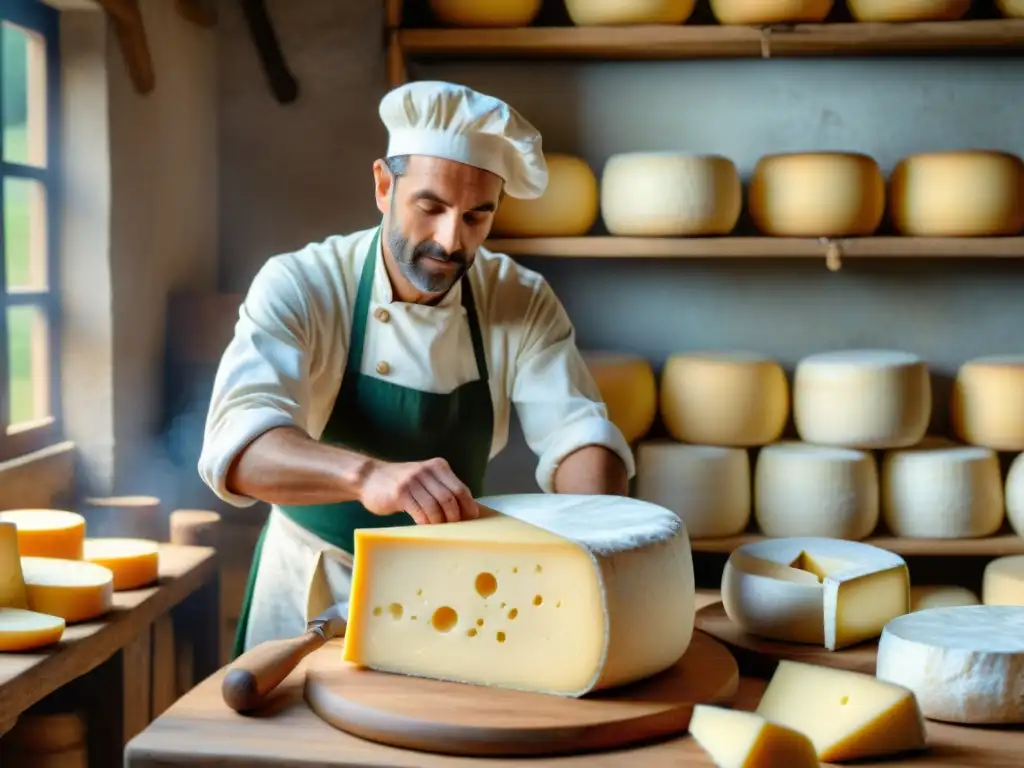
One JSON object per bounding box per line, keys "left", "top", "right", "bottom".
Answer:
{"left": 22, "top": 557, "right": 114, "bottom": 624}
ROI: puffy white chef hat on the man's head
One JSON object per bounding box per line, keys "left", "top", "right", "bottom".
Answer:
{"left": 380, "top": 81, "right": 548, "bottom": 200}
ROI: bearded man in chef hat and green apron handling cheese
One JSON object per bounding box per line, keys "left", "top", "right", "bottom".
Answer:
{"left": 199, "top": 82, "right": 634, "bottom": 654}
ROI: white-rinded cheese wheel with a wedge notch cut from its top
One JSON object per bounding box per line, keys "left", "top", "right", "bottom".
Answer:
{"left": 722, "top": 537, "right": 910, "bottom": 650}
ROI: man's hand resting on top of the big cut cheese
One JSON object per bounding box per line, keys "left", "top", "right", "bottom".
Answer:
{"left": 359, "top": 459, "right": 480, "bottom": 525}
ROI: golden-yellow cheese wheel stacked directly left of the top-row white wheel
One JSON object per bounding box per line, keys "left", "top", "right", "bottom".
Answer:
{"left": 659, "top": 352, "right": 790, "bottom": 446}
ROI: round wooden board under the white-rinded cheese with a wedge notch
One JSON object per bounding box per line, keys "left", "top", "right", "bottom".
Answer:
{"left": 696, "top": 602, "right": 879, "bottom": 675}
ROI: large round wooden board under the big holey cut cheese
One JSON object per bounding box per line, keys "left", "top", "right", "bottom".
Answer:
{"left": 305, "top": 632, "right": 739, "bottom": 757}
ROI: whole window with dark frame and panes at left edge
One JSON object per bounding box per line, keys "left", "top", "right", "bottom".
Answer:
{"left": 0, "top": 0, "right": 60, "bottom": 460}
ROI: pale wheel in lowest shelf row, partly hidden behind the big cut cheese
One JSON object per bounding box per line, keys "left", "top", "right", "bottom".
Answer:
{"left": 636, "top": 440, "right": 751, "bottom": 539}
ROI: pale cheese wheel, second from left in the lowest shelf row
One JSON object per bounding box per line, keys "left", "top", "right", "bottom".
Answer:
{"left": 754, "top": 442, "right": 879, "bottom": 540}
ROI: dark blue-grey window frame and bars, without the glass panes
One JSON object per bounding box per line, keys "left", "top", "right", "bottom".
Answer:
{"left": 0, "top": 0, "right": 63, "bottom": 461}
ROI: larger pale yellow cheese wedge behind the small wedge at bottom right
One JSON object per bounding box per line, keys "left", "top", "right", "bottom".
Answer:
{"left": 757, "top": 663, "right": 927, "bottom": 763}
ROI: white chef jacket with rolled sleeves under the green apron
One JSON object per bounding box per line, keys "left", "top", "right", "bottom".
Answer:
{"left": 199, "top": 227, "right": 636, "bottom": 507}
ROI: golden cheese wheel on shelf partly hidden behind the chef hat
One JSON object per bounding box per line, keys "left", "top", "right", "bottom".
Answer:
{"left": 490, "top": 154, "right": 598, "bottom": 238}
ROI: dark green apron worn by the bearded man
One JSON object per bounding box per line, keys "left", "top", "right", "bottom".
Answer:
{"left": 233, "top": 227, "right": 494, "bottom": 657}
